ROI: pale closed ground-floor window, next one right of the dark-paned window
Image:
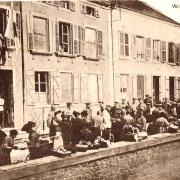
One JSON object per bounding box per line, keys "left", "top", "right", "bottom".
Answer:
{"left": 60, "top": 73, "right": 73, "bottom": 103}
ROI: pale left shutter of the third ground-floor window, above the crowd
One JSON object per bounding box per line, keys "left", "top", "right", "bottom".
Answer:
{"left": 81, "top": 74, "right": 88, "bottom": 101}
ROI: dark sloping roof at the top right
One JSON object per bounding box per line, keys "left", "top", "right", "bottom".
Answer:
{"left": 111, "top": 0, "right": 180, "bottom": 25}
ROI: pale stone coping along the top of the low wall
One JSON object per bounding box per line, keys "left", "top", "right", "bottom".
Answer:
{"left": 0, "top": 133, "right": 180, "bottom": 180}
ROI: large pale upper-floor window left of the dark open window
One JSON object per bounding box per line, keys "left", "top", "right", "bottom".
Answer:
{"left": 33, "top": 16, "right": 50, "bottom": 51}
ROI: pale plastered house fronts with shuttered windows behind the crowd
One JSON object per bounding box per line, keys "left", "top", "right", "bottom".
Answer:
{"left": 0, "top": 0, "right": 180, "bottom": 131}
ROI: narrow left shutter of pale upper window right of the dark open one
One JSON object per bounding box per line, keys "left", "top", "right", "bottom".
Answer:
{"left": 78, "top": 26, "right": 85, "bottom": 56}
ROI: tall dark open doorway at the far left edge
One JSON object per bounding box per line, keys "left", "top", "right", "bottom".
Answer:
{"left": 0, "top": 70, "right": 14, "bottom": 127}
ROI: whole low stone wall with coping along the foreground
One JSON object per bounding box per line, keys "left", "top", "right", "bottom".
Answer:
{"left": 0, "top": 133, "right": 180, "bottom": 180}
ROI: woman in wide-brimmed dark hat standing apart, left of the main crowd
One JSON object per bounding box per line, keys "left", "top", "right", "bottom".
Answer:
{"left": 21, "top": 121, "right": 42, "bottom": 159}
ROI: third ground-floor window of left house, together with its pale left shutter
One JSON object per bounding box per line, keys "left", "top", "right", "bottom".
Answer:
{"left": 81, "top": 74, "right": 99, "bottom": 102}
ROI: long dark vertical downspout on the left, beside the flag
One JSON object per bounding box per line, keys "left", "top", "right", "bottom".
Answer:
{"left": 19, "top": 1, "right": 25, "bottom": 122}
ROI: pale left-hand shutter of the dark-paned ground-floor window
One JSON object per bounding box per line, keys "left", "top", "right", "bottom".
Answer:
{"left": 26, "top": 71, "right": 35, "bottom": 106}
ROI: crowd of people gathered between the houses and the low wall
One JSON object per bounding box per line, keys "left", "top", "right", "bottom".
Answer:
{"left": 0, "top": 95, "right": 180, "bottom": 165}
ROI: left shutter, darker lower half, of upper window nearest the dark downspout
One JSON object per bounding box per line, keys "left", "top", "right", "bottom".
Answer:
{"left": 26, "top": 14, "right": 34, "bottom": 50}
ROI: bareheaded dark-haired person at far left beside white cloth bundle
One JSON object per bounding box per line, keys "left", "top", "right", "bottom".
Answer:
{"left": 0, "top": 129, "right": 18, "bottom": 165}
